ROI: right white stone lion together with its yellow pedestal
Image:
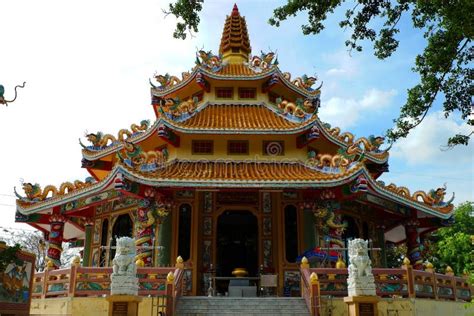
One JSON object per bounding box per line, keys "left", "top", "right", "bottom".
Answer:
{"left": 344, "top": 239, "right": 379, "bottom": 316}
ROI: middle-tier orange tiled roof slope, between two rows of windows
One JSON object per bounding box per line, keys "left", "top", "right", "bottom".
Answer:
{"left": 165, "top": 104, "right": 316, "bottom": 131}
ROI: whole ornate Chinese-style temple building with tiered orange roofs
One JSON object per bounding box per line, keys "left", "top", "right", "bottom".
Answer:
{"left": 16, "top": 6, "right": 453, "bottom": 295}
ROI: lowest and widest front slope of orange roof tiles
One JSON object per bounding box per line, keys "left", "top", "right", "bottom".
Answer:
{"left": 131, "top": 160, "right": 360, "bottom": 182}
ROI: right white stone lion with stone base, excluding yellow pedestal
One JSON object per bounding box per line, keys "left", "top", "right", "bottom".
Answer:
{"left": 347, "top": 239, "right": 376, "bottom": 296}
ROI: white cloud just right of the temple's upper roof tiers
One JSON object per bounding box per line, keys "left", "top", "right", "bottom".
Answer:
{"left": 319, "top": 88, "right": 397, "bottom": 129}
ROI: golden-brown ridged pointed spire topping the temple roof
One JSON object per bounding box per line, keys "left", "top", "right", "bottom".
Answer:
{"left": 219, "top": 4, "right": 252, "bottom": 64}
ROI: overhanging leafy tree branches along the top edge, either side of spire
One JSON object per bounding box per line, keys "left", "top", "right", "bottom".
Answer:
{"left": 166, "top": 0, "right": 474, "bottom": 146}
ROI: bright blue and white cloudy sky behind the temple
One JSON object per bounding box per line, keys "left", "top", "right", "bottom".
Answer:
{"left": 0, "top": 0, "right": 474, "bottom": 225}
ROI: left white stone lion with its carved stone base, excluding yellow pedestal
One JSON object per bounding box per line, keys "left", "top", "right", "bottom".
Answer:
{"left": 110, "top": 237, "right": 138, "bottom": 295}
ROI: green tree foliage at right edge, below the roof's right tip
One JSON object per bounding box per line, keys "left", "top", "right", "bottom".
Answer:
{"left": 425, "top": 202, "right": 474, "bottom": 275}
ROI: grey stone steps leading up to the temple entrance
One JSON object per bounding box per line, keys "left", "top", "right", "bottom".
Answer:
{"left": 176, "top": 296, "right": 309, "bottom": 316}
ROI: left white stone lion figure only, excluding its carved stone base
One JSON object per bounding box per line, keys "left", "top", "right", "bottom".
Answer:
{"left": 112, "top": 237, "right": 137, "bottom": 276}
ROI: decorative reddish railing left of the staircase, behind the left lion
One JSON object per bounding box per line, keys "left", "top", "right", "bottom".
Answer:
{"left": 32, "top": 259, "right": 184, "bottom": 315}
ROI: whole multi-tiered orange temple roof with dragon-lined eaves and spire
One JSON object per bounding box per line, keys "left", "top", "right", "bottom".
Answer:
{"left": 17, "top": 6, "right": 453, "bottom": 239}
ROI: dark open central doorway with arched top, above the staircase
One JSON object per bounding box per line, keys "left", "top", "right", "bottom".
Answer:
{"left": 216, "top": 211, "right": 258, "bottom": 276}
